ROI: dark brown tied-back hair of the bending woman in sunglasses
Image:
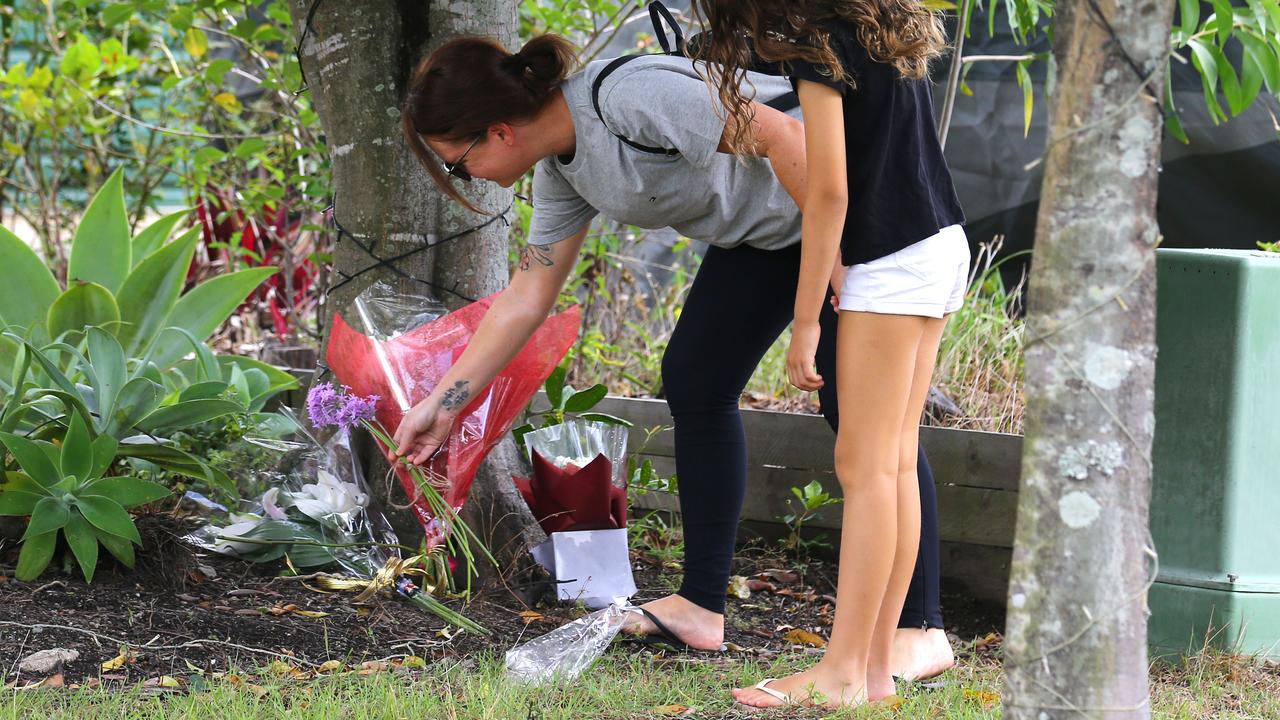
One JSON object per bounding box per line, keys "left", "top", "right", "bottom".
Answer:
{"left": 401, "top": 35, "right": 575, "bottom": 213}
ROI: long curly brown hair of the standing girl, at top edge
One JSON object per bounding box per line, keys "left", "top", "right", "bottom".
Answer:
{"left": 692, "top": 0, "right": 946, "bottom": 150}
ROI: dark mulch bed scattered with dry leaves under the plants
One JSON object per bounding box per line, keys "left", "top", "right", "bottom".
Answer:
{"left": 0, "top": 515, "right": 1002, "bottom": 687}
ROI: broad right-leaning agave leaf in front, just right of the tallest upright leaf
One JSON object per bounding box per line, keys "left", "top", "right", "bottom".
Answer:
{"left": 116, "top": 228, "right": 200, "bottom": 356}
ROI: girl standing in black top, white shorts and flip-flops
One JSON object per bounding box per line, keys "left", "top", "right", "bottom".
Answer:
{"left": 694, "top": 0, "right": 969, "bottom": 707}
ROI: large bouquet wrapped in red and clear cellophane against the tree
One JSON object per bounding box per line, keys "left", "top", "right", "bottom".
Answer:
{"left": 325, "top": 283, "right": 580, "bottom": 548}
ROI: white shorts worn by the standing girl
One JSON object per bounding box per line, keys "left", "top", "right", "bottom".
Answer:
{"left": 840, "top": 225, "right": 969, "bottom": 318}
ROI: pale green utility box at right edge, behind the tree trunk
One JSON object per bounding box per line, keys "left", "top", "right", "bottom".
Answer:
{"left": 1148, "top": 244, "right": 1280, "bottom": 659}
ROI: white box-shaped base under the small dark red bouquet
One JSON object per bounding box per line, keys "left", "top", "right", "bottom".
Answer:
{"left": 530, "top": 528, "right": 636, "bottom": 609}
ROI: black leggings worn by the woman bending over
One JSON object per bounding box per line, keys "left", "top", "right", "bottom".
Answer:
{"left": 662, "top": 245, "right": 942, "bottom": 628}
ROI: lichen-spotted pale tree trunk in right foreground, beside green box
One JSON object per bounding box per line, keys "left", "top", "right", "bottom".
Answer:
{"left": 1005, "top": 0, "right": 1174, "bottom": 720}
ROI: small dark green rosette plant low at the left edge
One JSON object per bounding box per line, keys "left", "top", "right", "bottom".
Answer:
{"left": 0, "top": 410, "right": 169, "bottom": 582}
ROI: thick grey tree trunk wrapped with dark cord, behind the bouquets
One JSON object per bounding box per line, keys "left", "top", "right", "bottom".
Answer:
{"left": 291, "top": 0, "right": 541, "bottom": 591}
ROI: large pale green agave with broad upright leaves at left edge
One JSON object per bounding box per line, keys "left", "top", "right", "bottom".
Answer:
{"left": 0, "top": 169, "right": 276, "bottom": 377}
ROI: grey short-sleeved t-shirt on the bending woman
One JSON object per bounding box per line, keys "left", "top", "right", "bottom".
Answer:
{"left": 529, "top": 55, "right": 800, "bottom": 250}
